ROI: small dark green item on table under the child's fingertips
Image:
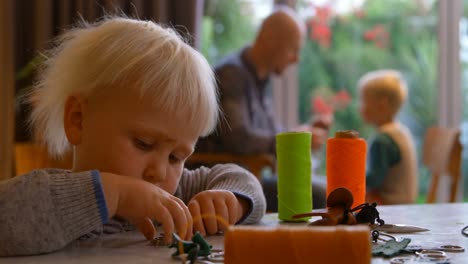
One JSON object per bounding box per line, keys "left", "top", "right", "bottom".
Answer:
{"left": 169, "top": 232, "right": 213, "bottom": 264}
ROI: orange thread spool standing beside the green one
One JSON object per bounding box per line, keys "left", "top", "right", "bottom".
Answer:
{"left": 326, "top": 131, "right": 367, "bottom": 207}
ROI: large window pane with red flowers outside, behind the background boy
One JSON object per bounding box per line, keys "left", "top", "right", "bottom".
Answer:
{"left": 298, "top": 0, "right": 437, "bottom": 202}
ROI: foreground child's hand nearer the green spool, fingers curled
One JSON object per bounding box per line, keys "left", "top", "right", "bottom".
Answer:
{"left": 188, "top": 190, "right": 247, "bottom": 235}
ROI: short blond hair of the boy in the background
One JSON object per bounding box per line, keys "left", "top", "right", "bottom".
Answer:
{"left": 358, "top": 70, "right": 408, "bottom": 115}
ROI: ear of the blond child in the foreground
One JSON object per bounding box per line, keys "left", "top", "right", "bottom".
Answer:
{"left": 63, "top": 96, "right": 83, "bottom": 146}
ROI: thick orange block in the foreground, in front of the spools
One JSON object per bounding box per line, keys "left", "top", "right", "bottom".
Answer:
{"left": 224, "top": 225, "right": 371, "bottom": 264}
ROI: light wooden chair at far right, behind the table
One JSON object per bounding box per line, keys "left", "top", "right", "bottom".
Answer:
{"left": 423, "top": 127, "right": 462, "bottom": 203}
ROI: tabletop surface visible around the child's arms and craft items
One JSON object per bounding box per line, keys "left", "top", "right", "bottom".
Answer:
{"left": 0, "top": 203, "right": 468, "bottom": 264}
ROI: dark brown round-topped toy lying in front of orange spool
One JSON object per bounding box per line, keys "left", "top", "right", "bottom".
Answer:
{"left": 293, "top": 188, "right": 384, "bottom": 225}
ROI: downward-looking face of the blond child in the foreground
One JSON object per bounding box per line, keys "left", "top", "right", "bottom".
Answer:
{"left": 69, "top": 87, "right": 199, "bottom": 194}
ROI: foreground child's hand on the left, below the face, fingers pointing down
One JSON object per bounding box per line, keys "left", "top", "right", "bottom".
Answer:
{"left": 101, "top": 173, "right": 193, "bottom": 243}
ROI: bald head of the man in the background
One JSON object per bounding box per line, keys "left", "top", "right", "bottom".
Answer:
{"left": 252, "top": 7, "right": 306, "bottom": 74}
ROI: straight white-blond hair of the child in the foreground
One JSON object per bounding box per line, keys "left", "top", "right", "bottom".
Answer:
{"left": 30, "top": 17, "right": 219, "bottom": 156}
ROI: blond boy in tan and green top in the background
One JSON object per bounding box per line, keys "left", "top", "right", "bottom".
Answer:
{"left": 358, "top": 70, "right": 418, "bottom": 204}
